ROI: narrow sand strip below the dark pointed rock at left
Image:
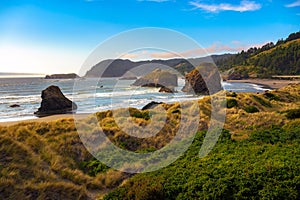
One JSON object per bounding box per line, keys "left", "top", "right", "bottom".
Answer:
{"left": 0, "top": 114, "right": 91, "bottom": 126}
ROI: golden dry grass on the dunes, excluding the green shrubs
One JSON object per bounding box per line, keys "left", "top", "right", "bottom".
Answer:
{"left": 0, "top": 84, "right": 300, "bottom": 199}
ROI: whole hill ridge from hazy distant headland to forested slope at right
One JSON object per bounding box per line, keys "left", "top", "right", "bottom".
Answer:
{"left": 85, "top": 32, "right": 300, "bottom": 79}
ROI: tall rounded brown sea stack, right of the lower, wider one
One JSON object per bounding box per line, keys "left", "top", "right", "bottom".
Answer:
{"left": 182, "top": 67, "right": 222, "bottom": 95}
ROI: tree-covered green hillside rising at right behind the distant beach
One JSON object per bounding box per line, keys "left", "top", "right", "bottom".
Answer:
{"left": 216, "top": 32, "right": 300, "bottom": 79}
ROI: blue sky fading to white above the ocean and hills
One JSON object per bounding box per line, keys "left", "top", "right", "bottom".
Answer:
{"left": 0, "top": 0, "right": 300, "bottom": 74}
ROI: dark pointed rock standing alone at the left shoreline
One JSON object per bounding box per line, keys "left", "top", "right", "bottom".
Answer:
{"left": 34, "top": 85, "right": 77, "bottom": 117}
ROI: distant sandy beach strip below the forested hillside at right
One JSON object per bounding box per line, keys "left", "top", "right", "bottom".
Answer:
{"left": 227, "top": 79, "right": 300, "bottom": 89}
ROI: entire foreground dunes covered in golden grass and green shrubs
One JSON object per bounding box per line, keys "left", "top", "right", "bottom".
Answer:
{"left": 0, "top": 84, "right": 300, "bottom": 199}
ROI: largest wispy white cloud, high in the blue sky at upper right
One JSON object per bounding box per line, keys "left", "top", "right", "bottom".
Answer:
{"left": 189, "top": 0, "right": 261, "bottom": 13}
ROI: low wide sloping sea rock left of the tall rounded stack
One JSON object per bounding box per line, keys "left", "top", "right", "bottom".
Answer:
{"left": 133, "top": 69, "right": 178, "bottom": 88}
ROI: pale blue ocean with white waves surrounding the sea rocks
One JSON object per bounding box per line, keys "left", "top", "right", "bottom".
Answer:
{"left": 0, "top": 77, "right": 266, "bottom": 122}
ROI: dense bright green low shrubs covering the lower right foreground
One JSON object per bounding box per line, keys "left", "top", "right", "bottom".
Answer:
{"left": 105, "top": 124, "right": 300, "bottom": 199}
